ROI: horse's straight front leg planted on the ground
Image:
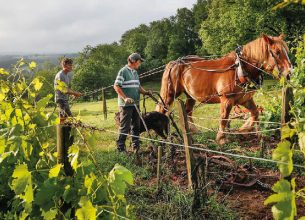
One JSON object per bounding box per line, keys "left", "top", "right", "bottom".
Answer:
{"left": 216, "top": 98, "right": 234, "bottom": 144}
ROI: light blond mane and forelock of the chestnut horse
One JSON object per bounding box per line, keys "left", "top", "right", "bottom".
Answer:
{"left": 243, "top": 37, "right": 289, "bottom": 63}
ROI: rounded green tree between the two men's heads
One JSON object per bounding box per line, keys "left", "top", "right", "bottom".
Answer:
{"left": 72, "top": 43, "right": 129, "bottom": 99}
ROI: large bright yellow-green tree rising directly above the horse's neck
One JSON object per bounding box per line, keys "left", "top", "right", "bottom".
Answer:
{"left": 199, "top": 0, "right": 286, "bottom": 54}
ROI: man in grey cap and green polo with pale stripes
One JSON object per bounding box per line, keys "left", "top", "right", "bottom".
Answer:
{"left": 113, "top": 53, "right": 151, "bottom": 152}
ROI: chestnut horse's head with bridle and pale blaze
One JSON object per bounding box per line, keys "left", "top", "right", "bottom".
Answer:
{"left": 262, "top": 34, "right": 292, "bottom": 80}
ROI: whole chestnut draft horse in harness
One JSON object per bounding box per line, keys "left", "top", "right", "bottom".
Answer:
{"left": 156, "top": 35, "right": 292, "bottom": 143}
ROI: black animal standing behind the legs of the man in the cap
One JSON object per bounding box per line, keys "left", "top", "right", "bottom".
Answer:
{"left": 115, "top": 111, "right": 169, "bottom": 139}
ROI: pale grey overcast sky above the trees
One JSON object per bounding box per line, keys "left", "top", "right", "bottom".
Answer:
{"left": 0, "top": 0, "right": 196, "bottom": 54}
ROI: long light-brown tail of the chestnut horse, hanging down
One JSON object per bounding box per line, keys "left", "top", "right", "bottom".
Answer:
{"left": 155, "top": 62, "right": 174, "bottom": 114}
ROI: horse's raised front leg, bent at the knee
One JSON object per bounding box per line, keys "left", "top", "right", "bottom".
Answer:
{"left": 239, "top": 99, "right": 259, "bottom": 131}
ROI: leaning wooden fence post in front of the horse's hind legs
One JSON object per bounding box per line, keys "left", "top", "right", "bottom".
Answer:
{"left": 178, "top": 100, "right": 196, "bottom": 189}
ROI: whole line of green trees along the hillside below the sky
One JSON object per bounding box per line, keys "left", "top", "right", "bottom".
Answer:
{"left": 33, "top": 0, "right": 305, "bottom": 99}
